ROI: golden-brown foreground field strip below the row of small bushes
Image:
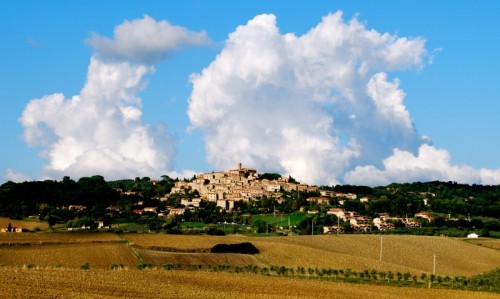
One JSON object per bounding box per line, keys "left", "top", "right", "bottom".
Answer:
{"left": 0, "top": 268, "right": 498, "bottom": 299}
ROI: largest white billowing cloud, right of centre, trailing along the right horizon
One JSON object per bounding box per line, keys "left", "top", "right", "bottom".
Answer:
{"left": 188, "top": 12, "right": 500, "bottom": 185}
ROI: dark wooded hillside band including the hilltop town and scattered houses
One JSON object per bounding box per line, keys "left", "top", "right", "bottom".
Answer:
{"left": 0, "top": 163, "right": 500, "bottom": 236}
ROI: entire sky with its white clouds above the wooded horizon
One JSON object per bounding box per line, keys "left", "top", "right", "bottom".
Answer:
{"left": 0, "top": 0, "right": 500, "bottom": 186}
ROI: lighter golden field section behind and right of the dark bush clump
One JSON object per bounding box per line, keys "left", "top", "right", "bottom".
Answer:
{"left": 125, "top": 234, "right": 500, "bottom": 276}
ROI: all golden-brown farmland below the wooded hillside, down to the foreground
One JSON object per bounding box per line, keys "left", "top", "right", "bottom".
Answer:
{"left": 0, "top": 233, "right": 500, "bottom": 298}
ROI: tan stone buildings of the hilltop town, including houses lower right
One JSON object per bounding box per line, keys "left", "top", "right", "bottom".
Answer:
{"left": 164, "top": 163, "right": 434, "bottom": 233}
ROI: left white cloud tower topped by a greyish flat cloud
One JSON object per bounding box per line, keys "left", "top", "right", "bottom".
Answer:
{"left": 20, "top": 16, "right": 209, "bottom": 178}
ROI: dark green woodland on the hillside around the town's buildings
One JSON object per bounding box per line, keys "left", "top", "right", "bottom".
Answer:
{"left": 0, "top": 174, "right": 500, "bottom": 236}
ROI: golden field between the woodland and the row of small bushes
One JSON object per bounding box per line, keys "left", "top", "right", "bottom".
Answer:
{"left": 0, "top": 233, "right": 500, "bottom": 276}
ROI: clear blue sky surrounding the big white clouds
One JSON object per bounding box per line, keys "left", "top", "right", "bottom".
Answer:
{"left": 0, "top": 0, "right": 500, "bottom": 185}
